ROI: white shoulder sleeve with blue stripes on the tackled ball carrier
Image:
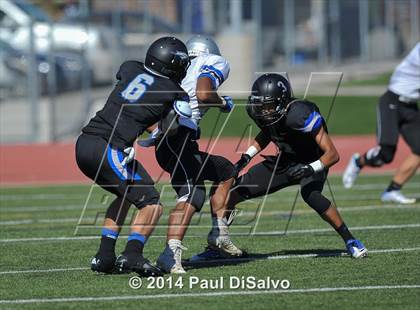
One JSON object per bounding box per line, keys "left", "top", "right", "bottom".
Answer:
{"left": 198, "top": 55, "right": 230, "bottom": 89}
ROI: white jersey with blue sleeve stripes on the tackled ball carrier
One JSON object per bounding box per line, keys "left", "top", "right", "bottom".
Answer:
{"left": 181, "top": 54, "right": 230, "bottom": 125}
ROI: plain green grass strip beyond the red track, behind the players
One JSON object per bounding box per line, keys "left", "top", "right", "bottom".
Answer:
{"left": 200, "top": 95, "right": 378, "bottom": 137}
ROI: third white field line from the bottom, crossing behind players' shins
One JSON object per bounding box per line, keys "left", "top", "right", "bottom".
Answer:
{"left": 0, "top": 223, "right": 420, "bottom": 243}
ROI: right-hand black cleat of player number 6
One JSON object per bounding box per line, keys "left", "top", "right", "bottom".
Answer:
{"left": 115, "top": 254, "right": 163, "bottom": 277}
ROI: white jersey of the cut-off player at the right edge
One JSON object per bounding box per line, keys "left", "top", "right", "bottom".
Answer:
{"left": 388, "top": 42, "right": 420, "bottom": 100}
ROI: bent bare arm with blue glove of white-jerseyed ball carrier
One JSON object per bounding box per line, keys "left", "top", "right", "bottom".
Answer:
{"left": 195, "top": 76, "right": 233, "bottom": 112}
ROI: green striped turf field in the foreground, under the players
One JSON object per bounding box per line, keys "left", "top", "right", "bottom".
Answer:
{"left": 0, "top": 175, "right": 420, "bottom": 309}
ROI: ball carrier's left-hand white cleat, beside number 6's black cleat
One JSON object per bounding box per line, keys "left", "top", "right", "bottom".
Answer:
{"left": 157, "top": 239, "right": 187, "bottom": 274}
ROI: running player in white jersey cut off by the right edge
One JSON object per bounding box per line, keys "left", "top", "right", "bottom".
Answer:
{"left": 343, "top": 42, "right": 420, "bottom": 204}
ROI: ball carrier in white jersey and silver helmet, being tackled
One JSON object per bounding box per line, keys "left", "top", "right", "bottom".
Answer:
{"left": 144, "top": 35, "right": 243, "bottom": 273}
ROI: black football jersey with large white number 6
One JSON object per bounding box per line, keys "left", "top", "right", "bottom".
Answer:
{"left": 82, "top": 61, "right": 188, "bottom": 148}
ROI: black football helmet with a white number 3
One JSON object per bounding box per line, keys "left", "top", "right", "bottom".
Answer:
{"left": 246, "top": 73, "right": 292, "bottom": 127}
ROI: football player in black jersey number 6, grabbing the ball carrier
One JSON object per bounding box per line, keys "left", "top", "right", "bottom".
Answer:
{"left": 76, "top": 37, "right": 191, "bottom": 276}
